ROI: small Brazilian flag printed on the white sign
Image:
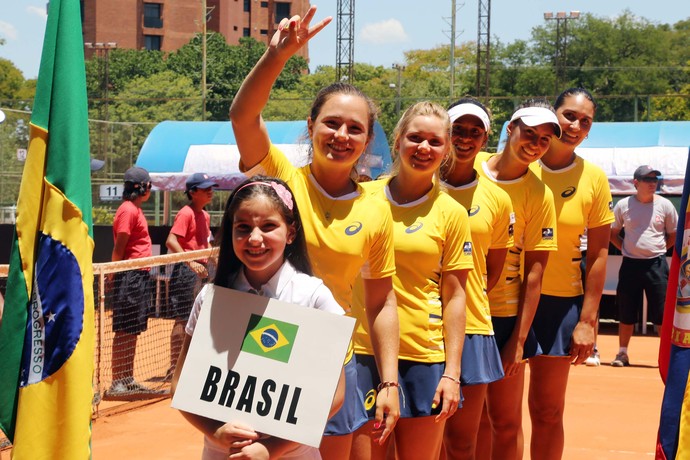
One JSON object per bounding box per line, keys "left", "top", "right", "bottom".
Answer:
{"left": 242, "top": 314, "right": 299, "bottom": 363}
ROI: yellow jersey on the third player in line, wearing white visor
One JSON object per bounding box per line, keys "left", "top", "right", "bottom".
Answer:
{"left": 444, "top": 172, "right": 515, "bottom": 335}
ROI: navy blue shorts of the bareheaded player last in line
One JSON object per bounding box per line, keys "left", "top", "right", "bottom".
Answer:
{"left": 532, "top": 294, "right": 584, "bottom": 356}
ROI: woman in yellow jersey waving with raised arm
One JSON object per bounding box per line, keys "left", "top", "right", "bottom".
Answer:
{"left": 230, "top": 7, "right": 399, "bottom": 459}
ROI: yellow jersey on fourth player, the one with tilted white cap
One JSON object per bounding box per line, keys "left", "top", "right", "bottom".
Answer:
{"left": 475, "top": 152, "right": 557, "bottom": 317}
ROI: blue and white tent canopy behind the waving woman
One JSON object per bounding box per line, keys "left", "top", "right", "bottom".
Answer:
{"left": 136, "top": 121, "right": 391, "bottom": 190}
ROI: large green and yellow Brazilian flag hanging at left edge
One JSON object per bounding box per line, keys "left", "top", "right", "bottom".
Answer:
{"left": 0, "top": 0, "right": 94, "bottom": 460}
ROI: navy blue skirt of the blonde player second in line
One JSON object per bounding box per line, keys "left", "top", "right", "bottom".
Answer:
{"left": 357, "top": 355, "right": 462, "bottom": 420}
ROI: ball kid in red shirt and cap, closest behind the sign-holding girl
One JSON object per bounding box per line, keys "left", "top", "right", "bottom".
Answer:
{"left": 165, "top": 173, "right": 218, "bottom": 380}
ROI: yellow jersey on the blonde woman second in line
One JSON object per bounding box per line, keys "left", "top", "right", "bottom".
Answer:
{"left": 354, "top": 178, "right": 474, "bottom": 363}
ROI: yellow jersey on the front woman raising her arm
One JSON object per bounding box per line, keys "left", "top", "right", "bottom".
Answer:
{"left": 250, "top": 145, "right": 395, "bottom": 314}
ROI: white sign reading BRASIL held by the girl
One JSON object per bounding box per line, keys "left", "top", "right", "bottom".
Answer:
{"left": 172, "top": 286, "right": 355, "bottom": 447}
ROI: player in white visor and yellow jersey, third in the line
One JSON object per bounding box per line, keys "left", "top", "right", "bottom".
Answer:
{"left": 442, "top": 98, "right": 515, "bottom": 459}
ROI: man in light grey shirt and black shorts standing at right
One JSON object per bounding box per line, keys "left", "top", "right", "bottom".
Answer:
{"left": 611, "top": 165, "right": 678, "bottom": 367}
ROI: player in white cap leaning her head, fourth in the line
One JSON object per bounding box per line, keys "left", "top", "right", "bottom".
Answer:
{"left": 475, "top": 100, "right": 561, "bottom": 460}
